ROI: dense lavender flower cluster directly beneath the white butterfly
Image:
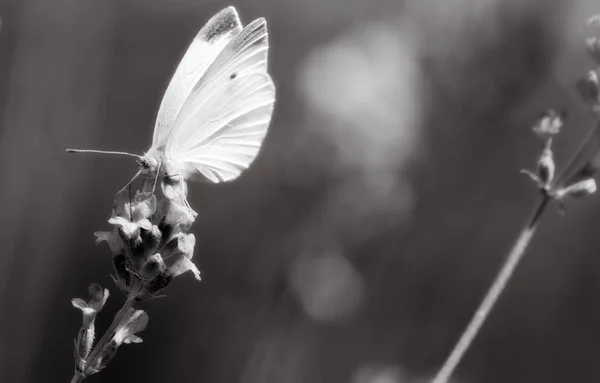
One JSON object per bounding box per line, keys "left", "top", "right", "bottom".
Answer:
{"left": 95, "top": 180, "right": 200, "bottom": 302}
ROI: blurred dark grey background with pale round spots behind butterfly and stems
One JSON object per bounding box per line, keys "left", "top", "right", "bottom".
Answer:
{"left": 0, "top": 0, "right": 600, "bottom": 383}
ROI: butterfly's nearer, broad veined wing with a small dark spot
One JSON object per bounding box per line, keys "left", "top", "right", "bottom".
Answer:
{"left": 165, "top": 19, "right": 275, "bottom": 182}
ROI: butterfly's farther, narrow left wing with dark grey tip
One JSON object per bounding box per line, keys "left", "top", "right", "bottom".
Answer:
{"left": 152, "top": 7, "right": 242, "bottom": 148}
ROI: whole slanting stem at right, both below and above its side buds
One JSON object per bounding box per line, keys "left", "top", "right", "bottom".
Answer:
{"left": 432, "top": 120, "right": 600, "bottom": 383}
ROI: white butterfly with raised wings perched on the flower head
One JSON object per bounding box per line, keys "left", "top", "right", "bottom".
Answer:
{"left": 67, "top": 7, "right": 275, "bottom": 214}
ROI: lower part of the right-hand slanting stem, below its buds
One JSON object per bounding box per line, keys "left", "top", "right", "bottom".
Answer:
{"left": 432, "top": 192, "right": 550, "bottom": 383}
